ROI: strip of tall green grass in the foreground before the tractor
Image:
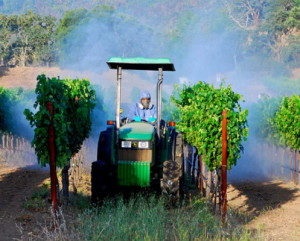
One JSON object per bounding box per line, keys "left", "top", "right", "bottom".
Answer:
{"left": 76, "top": 195, "right": 254, "bottom": 241}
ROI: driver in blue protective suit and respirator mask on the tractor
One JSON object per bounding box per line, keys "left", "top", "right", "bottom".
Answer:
{"left": 128, "top": 90, "right": 157, "bottom": 123}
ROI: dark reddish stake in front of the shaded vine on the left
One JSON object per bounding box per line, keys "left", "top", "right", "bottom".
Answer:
{"left": 46, "top": 102, "right": 59, "bottom": 216}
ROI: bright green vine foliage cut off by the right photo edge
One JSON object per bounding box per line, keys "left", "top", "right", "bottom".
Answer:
{"left": 272, "top": 95, "right": 300, "bottom": 150}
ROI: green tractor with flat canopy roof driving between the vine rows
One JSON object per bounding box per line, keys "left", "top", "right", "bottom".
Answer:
{"left": 91, "top": 58, "right": 184, "bottom": 202}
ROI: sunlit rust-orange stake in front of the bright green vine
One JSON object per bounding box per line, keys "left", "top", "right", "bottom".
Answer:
{"left": 220, "top": 110, "right": 228, "bottom": 223}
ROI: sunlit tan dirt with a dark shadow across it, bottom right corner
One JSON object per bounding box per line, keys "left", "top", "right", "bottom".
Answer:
{"left": 228, "top": 180, "right": 300, "bottom": 241}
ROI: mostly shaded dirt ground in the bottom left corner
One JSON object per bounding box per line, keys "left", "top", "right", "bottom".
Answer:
{"left": 0, "top": 165, "right": 49, "bottom": 241}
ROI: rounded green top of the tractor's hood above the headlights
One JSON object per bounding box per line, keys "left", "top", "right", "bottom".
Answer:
{"left": 119, "top": 122, "right": 155, "bottom": 141}
